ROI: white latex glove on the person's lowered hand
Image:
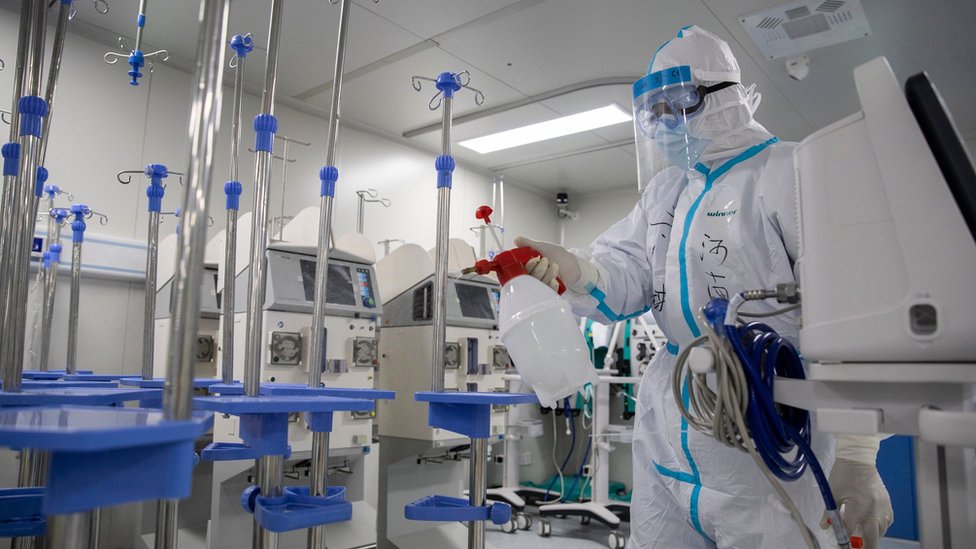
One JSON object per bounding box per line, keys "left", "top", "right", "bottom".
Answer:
{"left": 820, "top": 435, "right": 894, "bottom": 549}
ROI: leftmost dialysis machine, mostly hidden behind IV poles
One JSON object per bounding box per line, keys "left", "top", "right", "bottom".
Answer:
{"left": 153, "top": 229, "right": 223, "bottom": 378}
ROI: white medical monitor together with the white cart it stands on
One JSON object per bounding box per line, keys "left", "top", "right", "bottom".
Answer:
{"left": 775, "top": 58, "right": 976, "bottom": 548}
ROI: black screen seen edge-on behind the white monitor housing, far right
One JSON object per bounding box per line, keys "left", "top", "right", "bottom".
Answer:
{"left": 905, "top": 72, "right": 976, "bottom": 237}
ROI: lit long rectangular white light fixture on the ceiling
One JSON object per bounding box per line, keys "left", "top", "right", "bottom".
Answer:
{"left": 458, "top": 105, "right": 631, "bottom": 154}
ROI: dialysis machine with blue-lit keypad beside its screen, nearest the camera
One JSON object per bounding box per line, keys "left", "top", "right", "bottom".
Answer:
{"left": 211, "top": 208, "right": 382, "bottom": 549}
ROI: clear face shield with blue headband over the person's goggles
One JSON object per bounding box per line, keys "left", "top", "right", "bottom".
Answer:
{"left": 633, "top": 65, "right": 734, "bottom": 191}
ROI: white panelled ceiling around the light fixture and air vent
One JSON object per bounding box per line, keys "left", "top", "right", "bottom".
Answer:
{"left": 0, "top": 0, "right": 976, "bottom": 193}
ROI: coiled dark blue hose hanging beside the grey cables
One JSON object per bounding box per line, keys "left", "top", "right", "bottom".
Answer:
{"left": 724, "top": 322, "right": 837, "bottom": 511}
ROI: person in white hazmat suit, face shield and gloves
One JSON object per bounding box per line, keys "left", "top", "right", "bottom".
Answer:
{"left": 516, "top": 26, "right": 893, "bottom": 549}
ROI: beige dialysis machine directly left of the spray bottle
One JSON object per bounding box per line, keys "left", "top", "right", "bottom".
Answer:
{"left": 376, "top": 239, "right": 510, "bottom": 549}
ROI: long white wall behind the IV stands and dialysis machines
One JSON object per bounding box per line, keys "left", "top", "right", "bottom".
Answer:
{"left": 0, "top": 9, "right": 557, "bottom": 373}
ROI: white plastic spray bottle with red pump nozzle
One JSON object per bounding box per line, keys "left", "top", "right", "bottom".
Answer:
{"left": 464, "top": 248, "right": 598, "bottom": 408}
